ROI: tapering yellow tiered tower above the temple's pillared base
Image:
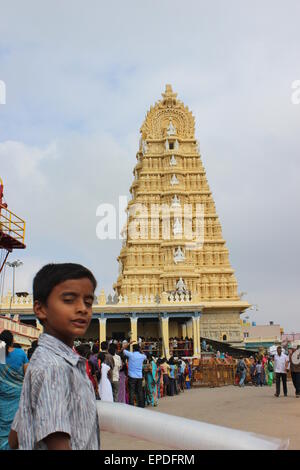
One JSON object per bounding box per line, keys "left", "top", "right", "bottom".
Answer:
{"left": 114, "top": 85, "right": 239, "bottom": 304}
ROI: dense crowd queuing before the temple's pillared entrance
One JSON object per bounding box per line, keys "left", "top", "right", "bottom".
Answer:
{"left": 74, "top": 338, "right": 192, "bottom": 407}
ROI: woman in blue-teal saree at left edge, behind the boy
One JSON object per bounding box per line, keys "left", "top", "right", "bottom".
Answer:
{"left": 0, "top": 330, "right": 28, "bottom": 450}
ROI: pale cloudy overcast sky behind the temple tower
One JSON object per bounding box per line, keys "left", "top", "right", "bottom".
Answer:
{"left": 0, "top": 0, "right": 300, "bottom": 332}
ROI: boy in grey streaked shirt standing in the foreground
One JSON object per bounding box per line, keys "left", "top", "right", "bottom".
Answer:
{"left": 9, "top": 263, "right": 100, "bottom": 450}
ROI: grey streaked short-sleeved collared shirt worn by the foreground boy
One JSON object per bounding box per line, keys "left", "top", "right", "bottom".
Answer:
{"left": 12, "top": 334, "right": 100, "bottom": 450}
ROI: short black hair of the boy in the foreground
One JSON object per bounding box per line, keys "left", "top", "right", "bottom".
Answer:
{"left": 33, "top": 263, "right": 97, "bottom": 304}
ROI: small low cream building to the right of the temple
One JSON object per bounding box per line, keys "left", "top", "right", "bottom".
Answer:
{"left": 241, "top": 320, "right": 283, "bottom": 351}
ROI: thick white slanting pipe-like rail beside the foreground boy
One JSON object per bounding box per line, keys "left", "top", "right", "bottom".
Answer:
{"left": 97, "top": 401, "right": 289, "bottom": 450}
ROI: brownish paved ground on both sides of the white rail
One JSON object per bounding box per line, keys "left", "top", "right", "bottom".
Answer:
{"left": 101, "top": 382, "right": 300, "bottom": 450}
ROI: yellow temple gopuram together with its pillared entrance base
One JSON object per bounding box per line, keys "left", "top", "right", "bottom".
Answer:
{"left": 0, "top": 85, "right": 250, "bottom": 357}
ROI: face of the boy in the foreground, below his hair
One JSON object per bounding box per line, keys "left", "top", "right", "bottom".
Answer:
{"left": 34, "top": 278, "right": 94, "bottom": 347}
